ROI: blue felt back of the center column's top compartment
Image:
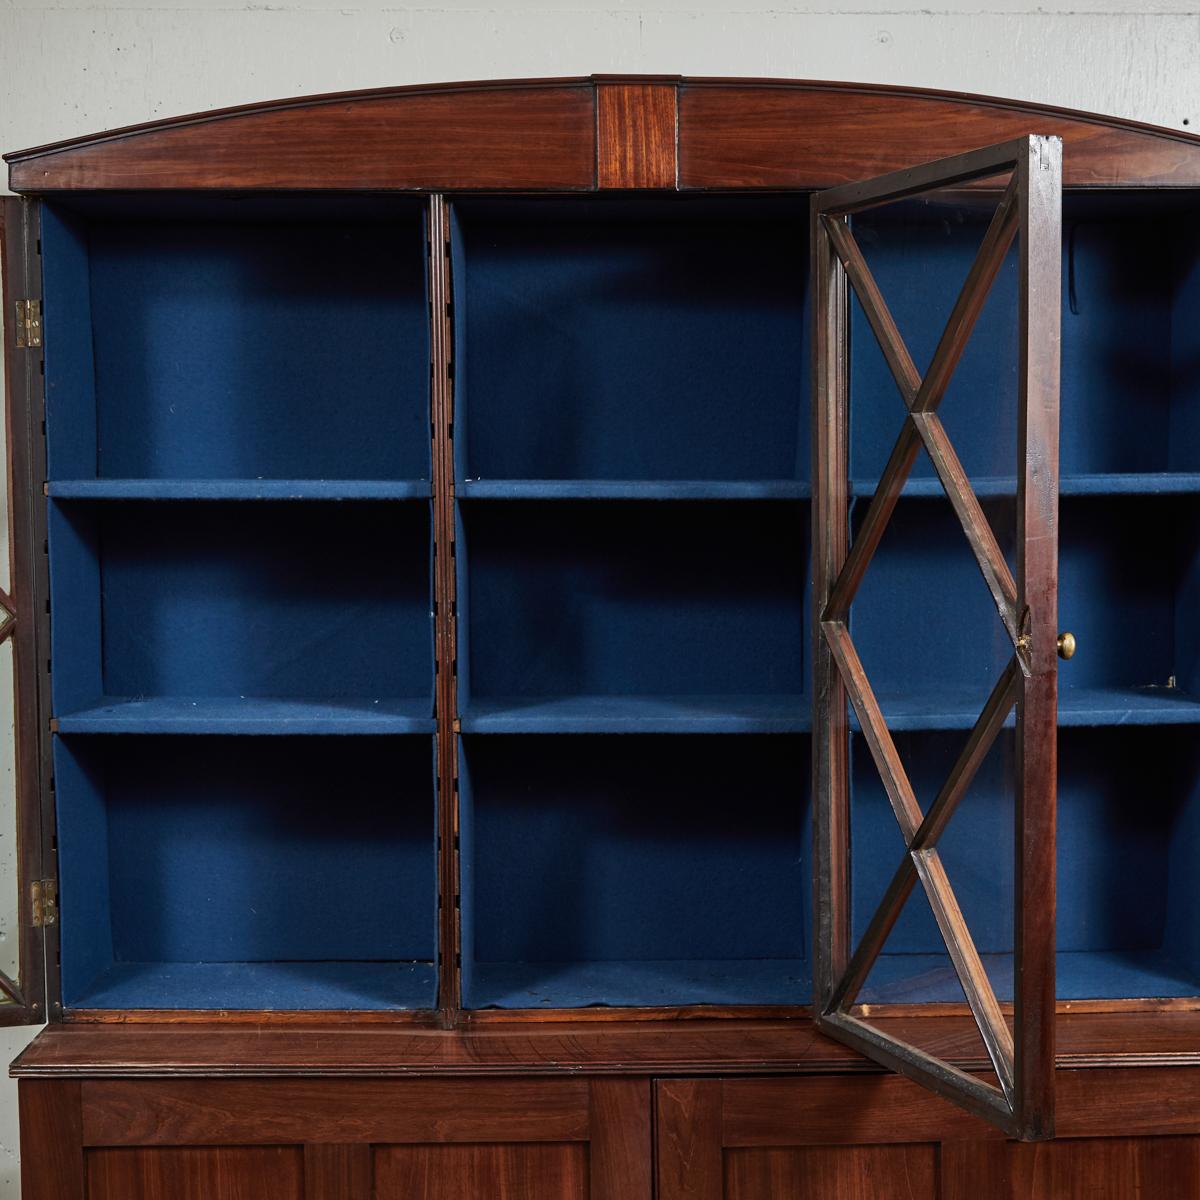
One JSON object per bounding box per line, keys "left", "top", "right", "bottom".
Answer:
{"left": 455, "top": 198, "right": 809, "bottom": 480}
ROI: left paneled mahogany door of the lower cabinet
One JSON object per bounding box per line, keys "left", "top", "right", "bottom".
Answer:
{"left": 20, "top": 1079, "right": 653, "bottom": 1200}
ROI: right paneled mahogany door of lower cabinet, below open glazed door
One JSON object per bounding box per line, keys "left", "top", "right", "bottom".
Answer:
{"left": 655, "top": 1068, "right": 1200, "bottom": 1200}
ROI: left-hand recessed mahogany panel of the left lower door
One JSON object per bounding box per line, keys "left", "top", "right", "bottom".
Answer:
{"left": 86, "top": 1146, "right": 300, "bottom": 1200}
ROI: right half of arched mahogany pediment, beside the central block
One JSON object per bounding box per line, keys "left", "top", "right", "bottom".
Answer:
{"left": 679, "top": 79, "right": 1200, "bottom": 188}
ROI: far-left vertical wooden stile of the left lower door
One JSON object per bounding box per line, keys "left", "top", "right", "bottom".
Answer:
{"left": 17, "top": 1079, "right": 85, "bottom": 1200}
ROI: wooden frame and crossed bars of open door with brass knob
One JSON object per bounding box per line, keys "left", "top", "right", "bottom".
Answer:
{"left": 812, "top": 136, "right": 1073, "bottom": 1139}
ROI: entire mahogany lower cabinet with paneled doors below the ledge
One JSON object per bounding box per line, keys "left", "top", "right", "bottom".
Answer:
{"left": 20, "top": 1068, "right": 1200, "bottom": 1200}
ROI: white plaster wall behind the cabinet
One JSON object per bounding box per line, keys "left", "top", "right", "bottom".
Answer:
{"left": 0, "top": 0, "right": 1200, "bottom": 1200}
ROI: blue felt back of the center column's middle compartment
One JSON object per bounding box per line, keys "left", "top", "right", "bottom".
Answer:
{"left": 458, "top": 502, "right": 809, "bottom": 697}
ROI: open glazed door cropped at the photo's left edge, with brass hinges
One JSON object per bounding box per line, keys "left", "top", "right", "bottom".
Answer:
{"left": 0, "top": 197, "right": 48, "bottom": 1025}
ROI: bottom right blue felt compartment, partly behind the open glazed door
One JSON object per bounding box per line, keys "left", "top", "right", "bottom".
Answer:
{"left": 852, "top": 726, "right": 1200, "bottom": 1003}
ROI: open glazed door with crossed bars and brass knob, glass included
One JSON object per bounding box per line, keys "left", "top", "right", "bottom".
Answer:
{"left": 812, "top": 136, "right": 1073, "bottom": 1139}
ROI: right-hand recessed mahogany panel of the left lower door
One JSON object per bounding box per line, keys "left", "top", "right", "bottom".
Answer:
{"left": 373, "top": 1144, "right": 585, "bottom": 1200}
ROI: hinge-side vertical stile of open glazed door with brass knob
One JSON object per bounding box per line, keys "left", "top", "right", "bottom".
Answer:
{"left": 810, "top": 194, "right": 851, "bottom": 1013}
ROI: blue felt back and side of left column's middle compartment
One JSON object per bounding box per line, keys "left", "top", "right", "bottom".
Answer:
{"left": 52, "top": 502, "right": 433, "bottom": 712}
